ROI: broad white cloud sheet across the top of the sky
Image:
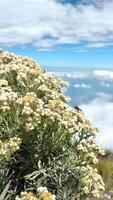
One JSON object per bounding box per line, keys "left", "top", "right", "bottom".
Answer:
{"left": 0, "top": 0, "right": 113, "bottom": 50}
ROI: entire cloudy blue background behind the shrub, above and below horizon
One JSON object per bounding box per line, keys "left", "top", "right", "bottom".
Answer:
{"left": 0, "top": 0, "right": 113, "bottom": 150}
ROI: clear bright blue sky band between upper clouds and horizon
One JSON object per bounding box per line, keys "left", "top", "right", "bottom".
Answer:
{"left": 4, "top": 45, "right": 113, "bottom": 69}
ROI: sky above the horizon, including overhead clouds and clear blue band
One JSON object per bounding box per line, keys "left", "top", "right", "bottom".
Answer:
{"left": 0, "top": 0, "right": 113, "bottom": 69}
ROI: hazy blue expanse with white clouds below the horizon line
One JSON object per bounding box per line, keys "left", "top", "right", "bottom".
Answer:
{"left": 50, "top": 70, "right": 113, "bottom": 150}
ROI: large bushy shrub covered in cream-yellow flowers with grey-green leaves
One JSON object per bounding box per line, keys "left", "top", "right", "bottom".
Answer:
{"left": 0, "top": 49, "right": 104, "bottom": 200}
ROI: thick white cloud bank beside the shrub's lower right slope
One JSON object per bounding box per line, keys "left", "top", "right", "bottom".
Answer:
{"left": 80, "top": 93, "right": 113, "bottom": 150}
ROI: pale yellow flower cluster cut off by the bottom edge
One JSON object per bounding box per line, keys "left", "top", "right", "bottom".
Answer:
{"left": 15, "top": 187, "right": 55, "bottom": 200}
